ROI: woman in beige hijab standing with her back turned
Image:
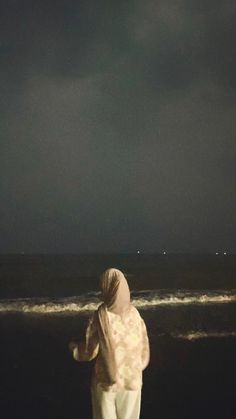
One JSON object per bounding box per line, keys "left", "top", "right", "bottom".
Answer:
{"left": 69, "top": 268, "right": 149, "bottom": 419}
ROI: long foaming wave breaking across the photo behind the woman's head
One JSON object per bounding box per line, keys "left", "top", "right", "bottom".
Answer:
{"left": 0, "top": 290, "right": 236, "bottom": 315}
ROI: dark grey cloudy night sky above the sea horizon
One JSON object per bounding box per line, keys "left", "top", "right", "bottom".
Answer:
{"left": 0, "top": 0, "right": 236, "bottom": 253}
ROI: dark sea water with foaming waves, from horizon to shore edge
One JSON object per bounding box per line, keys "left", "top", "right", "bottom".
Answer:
{"left": 0, "top": 254, "right": 236, "bottom": 340}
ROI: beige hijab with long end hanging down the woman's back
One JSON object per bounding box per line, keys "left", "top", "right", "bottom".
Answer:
{"left": 97, "top": 268, "right": 130, "bottom": 385}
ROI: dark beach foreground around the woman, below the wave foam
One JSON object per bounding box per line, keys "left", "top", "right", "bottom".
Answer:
{"left": 0, "top": 311, "right": 236, "bottom": 419}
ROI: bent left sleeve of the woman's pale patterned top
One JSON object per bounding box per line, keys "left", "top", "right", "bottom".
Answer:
{"left": 73, "top": 315, "right": 99, "bottom": 361}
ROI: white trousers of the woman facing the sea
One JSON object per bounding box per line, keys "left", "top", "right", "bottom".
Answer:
{"left": 91, "top": 384, "right": 141, "bottom": 419}
